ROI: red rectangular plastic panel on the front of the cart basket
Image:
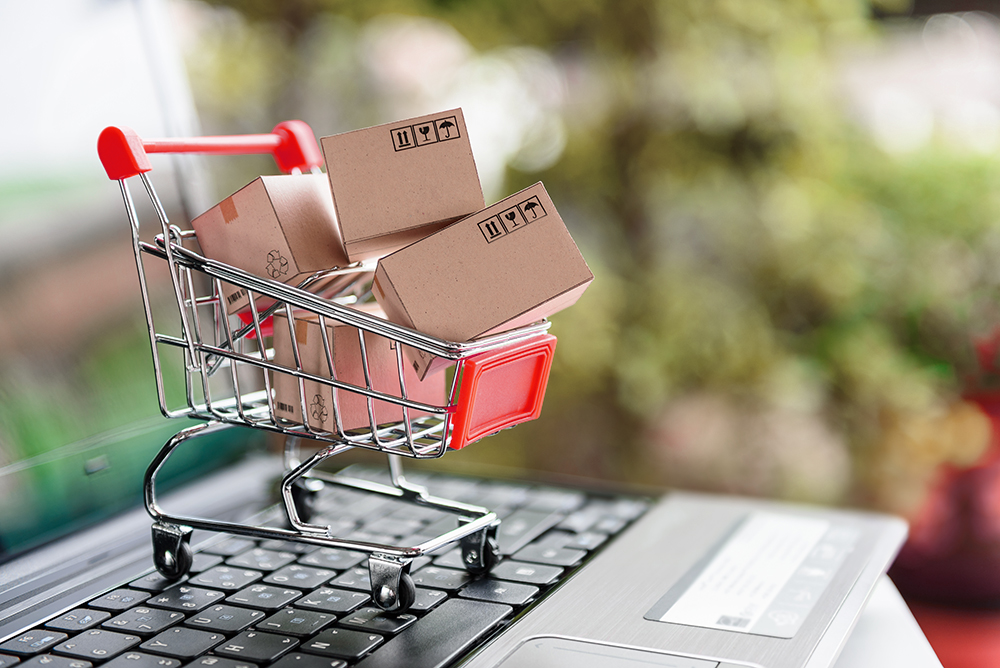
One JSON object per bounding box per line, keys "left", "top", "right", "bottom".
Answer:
{"left": 449, "top": 334, "right": 556, "bottom": 450}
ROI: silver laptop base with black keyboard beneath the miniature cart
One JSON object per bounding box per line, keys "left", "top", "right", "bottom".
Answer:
{"left": 0, "top": 428, "right": 906, "bottom": 668}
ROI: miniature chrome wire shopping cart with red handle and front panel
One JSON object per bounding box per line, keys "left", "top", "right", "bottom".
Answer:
{"left": 98, "top": 121, "right": 555, "bottom": 611}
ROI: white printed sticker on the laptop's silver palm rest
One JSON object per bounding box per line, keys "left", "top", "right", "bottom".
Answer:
{"left": 646, "top": 513, "right": 859, "bottom": 638}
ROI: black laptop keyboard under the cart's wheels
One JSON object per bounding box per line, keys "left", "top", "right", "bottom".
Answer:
{"left": 0, "top": 468, "right": 649, "bottom": 668}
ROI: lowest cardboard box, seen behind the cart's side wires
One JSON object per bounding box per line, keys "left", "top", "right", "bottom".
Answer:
{"left": 273, "top": 304, "right": 445, "bottom": 432}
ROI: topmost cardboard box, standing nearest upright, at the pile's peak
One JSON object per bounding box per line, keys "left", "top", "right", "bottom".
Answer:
{"left": 320, "top": 109, "right": 485, "bottom": 262}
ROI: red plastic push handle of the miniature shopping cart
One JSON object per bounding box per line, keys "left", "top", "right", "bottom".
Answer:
{"left": 97, "top": 121, "right": 323, "bottom": 181}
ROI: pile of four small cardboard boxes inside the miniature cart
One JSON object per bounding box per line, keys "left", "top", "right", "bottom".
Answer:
{"left": 193, "top": 109, "right": 593, "bottom": 431}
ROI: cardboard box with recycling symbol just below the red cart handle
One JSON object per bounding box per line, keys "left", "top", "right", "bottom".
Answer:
{"left": 191, "top": 174, "right": 349, "bottom": 314}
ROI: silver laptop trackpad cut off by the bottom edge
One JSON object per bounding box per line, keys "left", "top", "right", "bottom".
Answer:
{"left": 497, "top": 636, "right": 719, "bottom": 668}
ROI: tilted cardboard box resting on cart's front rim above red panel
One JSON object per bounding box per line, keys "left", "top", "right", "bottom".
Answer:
{"left": 372, "top": 183, "right": 594, "bottom": 378}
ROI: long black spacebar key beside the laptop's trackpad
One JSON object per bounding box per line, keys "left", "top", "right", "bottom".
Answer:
{"left": 357, "top": 598, "right": 513, "bottom": 668}
